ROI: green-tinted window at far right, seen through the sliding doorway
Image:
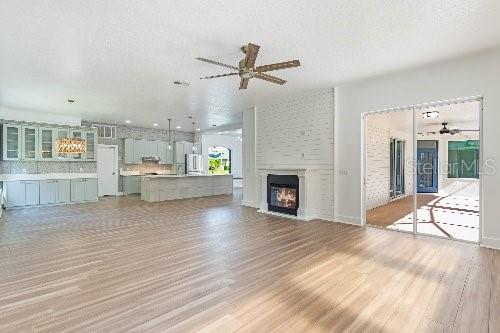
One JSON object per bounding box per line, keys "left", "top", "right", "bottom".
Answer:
{"left": 448, "top": 140, "right": 479, "bottom": 178}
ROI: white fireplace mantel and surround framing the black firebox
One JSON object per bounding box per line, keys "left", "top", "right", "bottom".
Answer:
{"left": 258, "top": 167, "right": 317, "bottom": 221}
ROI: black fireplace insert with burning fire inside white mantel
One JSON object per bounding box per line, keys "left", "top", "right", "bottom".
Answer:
{"left": 267, "top": 175, "right": 299, "bottom": 216}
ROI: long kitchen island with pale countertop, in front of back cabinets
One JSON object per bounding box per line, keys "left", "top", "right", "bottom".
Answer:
{"left": 141, "top": 175, "right": 233, "bottom": 202}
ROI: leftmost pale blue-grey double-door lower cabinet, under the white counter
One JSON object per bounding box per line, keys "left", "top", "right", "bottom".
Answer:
{"left": 4, "top": 181, "right": 40, "bottom": 207}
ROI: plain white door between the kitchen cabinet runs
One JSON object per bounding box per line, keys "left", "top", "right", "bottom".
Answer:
{"left": 97, "top": 145, "right": 118, "bottom": 197}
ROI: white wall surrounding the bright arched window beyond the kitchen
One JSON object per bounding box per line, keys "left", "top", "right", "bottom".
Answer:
{"left": 201, "top": 134, "right": 243, "bottom": 178}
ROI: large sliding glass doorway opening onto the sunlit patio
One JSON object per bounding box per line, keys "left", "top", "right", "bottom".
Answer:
{"left": 362, "top": 98, "right": 482, "bottom": 242}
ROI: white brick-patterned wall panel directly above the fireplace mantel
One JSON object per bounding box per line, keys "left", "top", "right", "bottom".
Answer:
{"left": 256, "top": 91, "right": 334, "bottom": 169}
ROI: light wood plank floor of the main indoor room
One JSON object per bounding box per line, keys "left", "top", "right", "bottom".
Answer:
{"left": 0, "top": 188, "right": 500, "bottom": 332}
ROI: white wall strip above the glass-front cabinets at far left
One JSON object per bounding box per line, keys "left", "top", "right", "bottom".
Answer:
{"left": 0, "top": 106, "right": 82, "bottom": 126}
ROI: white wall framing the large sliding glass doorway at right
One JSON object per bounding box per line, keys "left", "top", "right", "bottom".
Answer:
{"left": 335, "top": 51, "right": 500, "bottom": 248}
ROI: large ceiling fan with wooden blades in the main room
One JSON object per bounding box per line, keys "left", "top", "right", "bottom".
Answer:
{"left": 196, "top": 43, "right": 300, "bottom": 89}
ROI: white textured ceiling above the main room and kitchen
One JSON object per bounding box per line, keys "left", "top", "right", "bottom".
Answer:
{"left": 0, "top": 0, "right": 500, "bottom": 131}
